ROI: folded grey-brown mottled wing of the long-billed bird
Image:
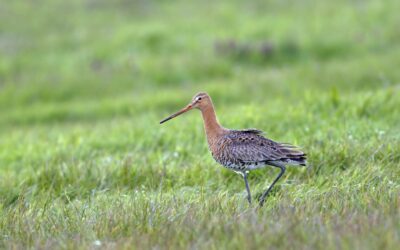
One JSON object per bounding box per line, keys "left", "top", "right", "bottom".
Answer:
{"left": 224, "top": 130, "right": 305, "bottom": 163}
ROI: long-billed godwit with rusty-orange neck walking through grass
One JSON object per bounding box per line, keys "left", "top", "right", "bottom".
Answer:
{"left": 160, "top": 93, "right": 306, "bottom": 206}
